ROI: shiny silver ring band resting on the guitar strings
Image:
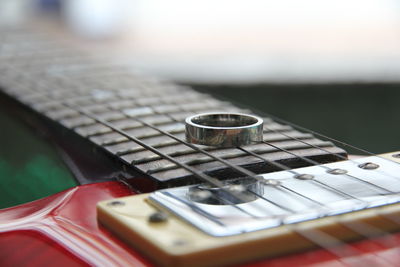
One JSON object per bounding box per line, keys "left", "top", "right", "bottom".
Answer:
{"left": 186, "top": 112, "right": 263, "bottom": 147}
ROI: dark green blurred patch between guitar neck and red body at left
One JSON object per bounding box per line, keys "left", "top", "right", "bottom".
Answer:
{"left": 0, "top": 111, "right": 77, "bottom": 208}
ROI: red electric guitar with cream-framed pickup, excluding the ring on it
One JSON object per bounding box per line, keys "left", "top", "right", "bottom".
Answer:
{"left": 0, "top": 25, "right": 400, "bottom": 266}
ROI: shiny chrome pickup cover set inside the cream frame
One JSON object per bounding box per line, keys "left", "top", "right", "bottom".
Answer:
{"left": 149, "top": 156, "right": 400, "bottom": 237}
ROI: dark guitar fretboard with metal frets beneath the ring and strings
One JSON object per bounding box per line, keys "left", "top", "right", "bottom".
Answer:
{"left": 0, "top": 26, "right": 346, "bottom": 184}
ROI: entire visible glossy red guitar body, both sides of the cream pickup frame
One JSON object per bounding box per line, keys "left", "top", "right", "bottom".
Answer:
{"left": 0, "top": 182, "right": 400, "bottom": 267}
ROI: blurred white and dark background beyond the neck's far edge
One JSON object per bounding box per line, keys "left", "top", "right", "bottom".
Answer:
{"left": 0, "top": 0, "right": 400, "bottom": 152}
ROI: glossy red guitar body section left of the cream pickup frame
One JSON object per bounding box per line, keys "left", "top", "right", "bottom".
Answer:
{"left": 0, "top": 182, "right": 152, "bottom": 267}
